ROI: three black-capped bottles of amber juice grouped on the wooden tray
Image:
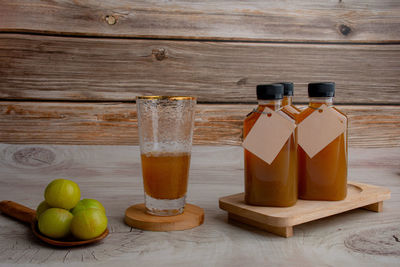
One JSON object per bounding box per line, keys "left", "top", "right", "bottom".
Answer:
{"left": 243, "top": 83, "right": 347, "bottom": 207}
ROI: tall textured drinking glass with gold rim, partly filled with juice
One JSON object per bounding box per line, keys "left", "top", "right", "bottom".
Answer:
{"left": 136, "top": 96, "right": 196, "bottom": 216}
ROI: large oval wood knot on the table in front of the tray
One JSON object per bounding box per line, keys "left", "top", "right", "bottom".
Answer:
{"left": 344, "top": 226, "right": 400, "bottom": 256}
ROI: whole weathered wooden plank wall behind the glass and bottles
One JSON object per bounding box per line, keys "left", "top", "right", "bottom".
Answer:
{"left": 0, "top": 0, "right": 400, "bottom": 147}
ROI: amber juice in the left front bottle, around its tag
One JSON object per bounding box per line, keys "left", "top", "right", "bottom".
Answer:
{"left": 243, "top": 100, "right": 297, "bottom": 207}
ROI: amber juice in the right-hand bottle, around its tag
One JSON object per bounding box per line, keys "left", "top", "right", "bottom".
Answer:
{"left": 298, "top": 98, "right": 347, "bottom": 200}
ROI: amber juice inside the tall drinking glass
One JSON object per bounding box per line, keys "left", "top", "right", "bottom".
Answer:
{"left": 141, "top": 152, "right": 190, "bottom": 199}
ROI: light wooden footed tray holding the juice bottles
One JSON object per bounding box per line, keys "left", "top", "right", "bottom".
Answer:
{"left": 219, "top": 182, "right": 390, "bottom": 237}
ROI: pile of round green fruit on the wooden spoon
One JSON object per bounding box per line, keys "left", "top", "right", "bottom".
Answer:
{"left": 36, "top": 179, "right": 107, "bottom": 240}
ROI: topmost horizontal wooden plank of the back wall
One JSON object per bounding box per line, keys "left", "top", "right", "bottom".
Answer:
{"left": 0, "top": 0, "right": 400, "bottom": 42}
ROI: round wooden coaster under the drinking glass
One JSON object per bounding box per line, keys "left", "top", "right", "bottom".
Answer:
{"left": 125, "top": 203, "right": 204, "bottom": 232}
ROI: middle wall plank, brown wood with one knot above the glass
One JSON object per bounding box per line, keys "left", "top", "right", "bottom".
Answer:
{"left": 0, "top": 34, "right": 400, "bottom": 104}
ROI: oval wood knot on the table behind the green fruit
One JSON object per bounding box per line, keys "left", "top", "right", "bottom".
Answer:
{"left": 13, "top": 147, "right": 56, "bottom": 167}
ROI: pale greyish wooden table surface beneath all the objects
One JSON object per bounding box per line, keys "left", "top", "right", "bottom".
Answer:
{"left": 0, "top": 144, "right": 400, "bottom": 266}
